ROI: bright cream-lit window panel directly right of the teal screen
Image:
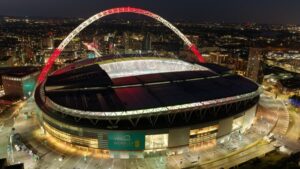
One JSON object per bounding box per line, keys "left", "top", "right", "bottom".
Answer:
{"left": 145, "top": 134, "right": 169, "bottom": 150}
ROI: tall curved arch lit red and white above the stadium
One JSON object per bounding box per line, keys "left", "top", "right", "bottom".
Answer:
{"left": 38, "top": 7, "right": 205, "bottom": 83}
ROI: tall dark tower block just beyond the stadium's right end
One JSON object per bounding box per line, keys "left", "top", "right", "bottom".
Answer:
{"left": 247, "top": 48, "right": 263, "bottom": 83}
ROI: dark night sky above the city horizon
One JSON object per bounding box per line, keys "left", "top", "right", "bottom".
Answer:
{"left": 0, "top": 0, "right": 300, "bottom": 24}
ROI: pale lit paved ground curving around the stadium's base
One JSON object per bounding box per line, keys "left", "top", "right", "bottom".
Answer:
{"left": 0, "top": 92, "right": 299, "bottom": 169}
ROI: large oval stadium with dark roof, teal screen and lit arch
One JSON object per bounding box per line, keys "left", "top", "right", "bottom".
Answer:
{"left": 35, "top": 7, "right": 260, "bottom": 156}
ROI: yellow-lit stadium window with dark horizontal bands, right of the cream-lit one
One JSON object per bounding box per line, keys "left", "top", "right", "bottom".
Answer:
{"left": 189, "top": 125, "right": 218, "bottom": 145}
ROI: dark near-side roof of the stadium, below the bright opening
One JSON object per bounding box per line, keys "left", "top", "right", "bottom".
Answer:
{"left": 45, "top": 64, "right": 258, "bottom": 112}
